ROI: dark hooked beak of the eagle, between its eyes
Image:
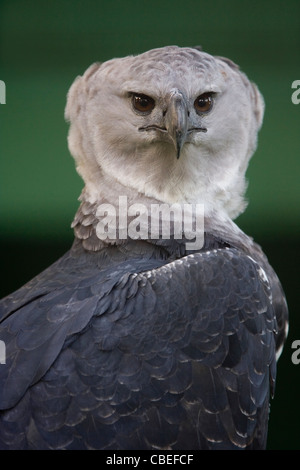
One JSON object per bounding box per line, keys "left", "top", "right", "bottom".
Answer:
{"left": 166, "top": 90, "right": 188, "bottom": 159}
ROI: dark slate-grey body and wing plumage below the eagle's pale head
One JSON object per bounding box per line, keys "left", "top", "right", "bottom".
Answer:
{"left": 0, "top": 48, "right": 287, "bottom": 450}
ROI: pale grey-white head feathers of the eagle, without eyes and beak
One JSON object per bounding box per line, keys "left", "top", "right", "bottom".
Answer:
{"left": 66, "top": 46, "right": 264, "bottom": 218}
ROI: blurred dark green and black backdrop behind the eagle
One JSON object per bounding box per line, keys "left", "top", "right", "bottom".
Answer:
{"left": 0, "top": 0, "right": 300, "bottom": 449}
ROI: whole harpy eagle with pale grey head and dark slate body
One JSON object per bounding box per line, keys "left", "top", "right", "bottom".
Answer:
{"left": 0, "top": 46, "right": 288, "bottom": 450}
